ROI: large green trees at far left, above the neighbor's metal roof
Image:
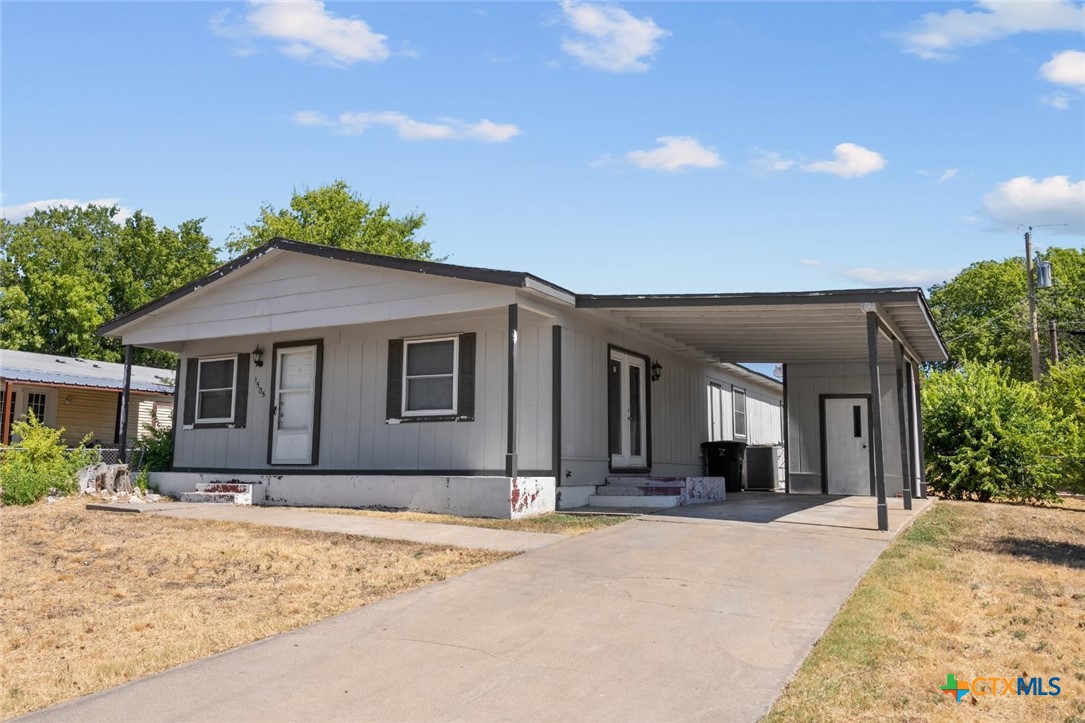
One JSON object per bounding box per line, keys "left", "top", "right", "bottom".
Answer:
{"left": 0, "top": 205, "right": 216, "bottom": 367}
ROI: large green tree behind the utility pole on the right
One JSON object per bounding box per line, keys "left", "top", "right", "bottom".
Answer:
{"left": 930, "top": 248, "right": 1085, "bottom": 379}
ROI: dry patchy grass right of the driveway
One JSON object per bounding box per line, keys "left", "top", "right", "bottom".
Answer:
{"left": 768, "top": 499, "right": 1085, "bottom": 723}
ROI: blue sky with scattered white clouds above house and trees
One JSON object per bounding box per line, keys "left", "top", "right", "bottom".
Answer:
{"left": 0, "top": 0, "right": 1085, "bottom": 293}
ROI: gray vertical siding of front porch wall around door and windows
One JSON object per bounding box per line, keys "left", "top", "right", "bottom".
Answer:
{"left": 175, "top": 315, "right": 550, "bottom": 471}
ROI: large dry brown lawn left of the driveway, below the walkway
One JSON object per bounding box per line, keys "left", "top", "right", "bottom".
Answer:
{"left": 0, "top": 499, "right": 510, "bottom": 718}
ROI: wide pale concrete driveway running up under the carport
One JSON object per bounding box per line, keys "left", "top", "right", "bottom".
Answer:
{"left": 31, "top": 493, "right": 927, "bottom": 722}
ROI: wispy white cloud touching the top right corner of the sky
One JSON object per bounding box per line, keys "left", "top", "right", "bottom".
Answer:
{"left": 896, "top": 0, "right": 1085, "bottom": 60}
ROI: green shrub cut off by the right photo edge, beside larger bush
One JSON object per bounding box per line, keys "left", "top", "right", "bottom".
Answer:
{"left": 1039, "top": 357, "right": 1085, "bottom": 494}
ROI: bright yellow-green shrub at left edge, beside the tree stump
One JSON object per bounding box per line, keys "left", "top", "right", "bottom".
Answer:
{"left": 0, "top": 411, "right": 98, "bottom": 505}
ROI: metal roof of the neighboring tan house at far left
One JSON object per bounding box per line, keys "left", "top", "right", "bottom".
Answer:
{"left": 0, "top": 350, "right": 174, "bottom": 394}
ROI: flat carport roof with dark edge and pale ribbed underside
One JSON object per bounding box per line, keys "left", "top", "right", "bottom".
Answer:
{"left": 576, "top": 289, "right": 948, "bottom": 363}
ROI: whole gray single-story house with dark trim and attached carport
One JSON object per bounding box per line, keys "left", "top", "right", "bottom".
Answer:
{"left": 100, "top": 239, "right": 946, "bottom": 517}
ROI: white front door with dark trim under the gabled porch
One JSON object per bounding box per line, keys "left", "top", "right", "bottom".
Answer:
{"left": 271, "top": 346, "right": 317, "bottom": 465}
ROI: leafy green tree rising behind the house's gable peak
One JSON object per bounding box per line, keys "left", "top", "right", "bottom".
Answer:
{"left": 226, "top": 180, "right": 433, "bottom": 259}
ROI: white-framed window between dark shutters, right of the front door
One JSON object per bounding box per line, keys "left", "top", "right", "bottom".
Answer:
{"left": 401, "top": 337, "right": 460, "bottom": 417}
